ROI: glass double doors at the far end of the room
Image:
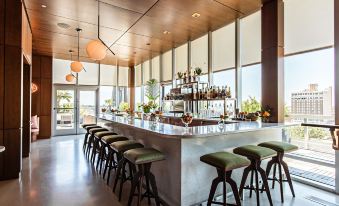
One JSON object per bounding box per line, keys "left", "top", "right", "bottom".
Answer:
{"left": 53, "top": 85, "right": 98, "bottom": 136}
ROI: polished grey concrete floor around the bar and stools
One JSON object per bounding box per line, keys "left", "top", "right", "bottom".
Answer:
{"left": 0, "top": 135, "right": 339, "bottom": 206}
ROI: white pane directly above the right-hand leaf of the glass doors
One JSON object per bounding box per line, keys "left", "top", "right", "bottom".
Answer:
{"left": 78, "top": 62, "right": 99, "bottom": 85}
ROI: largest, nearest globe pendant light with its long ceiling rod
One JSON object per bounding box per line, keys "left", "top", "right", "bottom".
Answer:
{"left": 86, "top": 1, "right": 115, "bottom": 61}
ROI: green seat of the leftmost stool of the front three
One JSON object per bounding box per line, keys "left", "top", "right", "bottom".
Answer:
{"left": 200, "top": 152, "right": 251, "bottom": 171}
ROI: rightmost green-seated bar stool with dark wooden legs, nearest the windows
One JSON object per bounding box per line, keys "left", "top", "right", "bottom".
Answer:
{"left": 259, "top": 141, "right": 298, "bottom": 202}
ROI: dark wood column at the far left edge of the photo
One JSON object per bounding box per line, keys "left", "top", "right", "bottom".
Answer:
{"left": 0, "top": 0, "right": 23, "bottom": 180}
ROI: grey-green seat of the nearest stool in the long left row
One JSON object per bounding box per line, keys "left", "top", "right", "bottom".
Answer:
{"left": 124, "top": 148, "right": 165, "bottom": 165}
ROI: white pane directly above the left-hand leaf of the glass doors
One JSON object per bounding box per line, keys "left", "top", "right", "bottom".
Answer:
{"left": 53, "top": 58, "right": 76, "bottom": 84}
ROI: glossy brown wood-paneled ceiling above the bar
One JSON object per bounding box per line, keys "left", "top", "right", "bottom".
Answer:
{"left": 25, "top": 0, "right": 261, "bottom": 66}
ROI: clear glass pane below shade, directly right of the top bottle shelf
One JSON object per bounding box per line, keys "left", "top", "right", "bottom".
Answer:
{"left": 213, "top": 69, "right": 235, "bottom": 97}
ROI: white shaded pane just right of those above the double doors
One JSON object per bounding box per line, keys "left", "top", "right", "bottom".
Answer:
{"left": 100, "top": 64, "right": 118, "bottom": 86}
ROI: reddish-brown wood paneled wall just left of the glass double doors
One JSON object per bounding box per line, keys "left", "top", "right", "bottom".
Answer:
{"left": 32, "top": 54, "right": 53, "bottom": 139}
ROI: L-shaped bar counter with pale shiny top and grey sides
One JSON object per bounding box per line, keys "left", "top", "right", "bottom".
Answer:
{"left": 97, "top": 114, "right": 292, "bottom": 206}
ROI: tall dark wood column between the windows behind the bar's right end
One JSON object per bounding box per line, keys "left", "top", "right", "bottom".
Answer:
{"left": 261, "top": 0, "right": 284, "bottom": 122}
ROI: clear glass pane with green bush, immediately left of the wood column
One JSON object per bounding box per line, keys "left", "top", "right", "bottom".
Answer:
{"left": 241, "top": 64, "right": 261, "bottom": 112}
